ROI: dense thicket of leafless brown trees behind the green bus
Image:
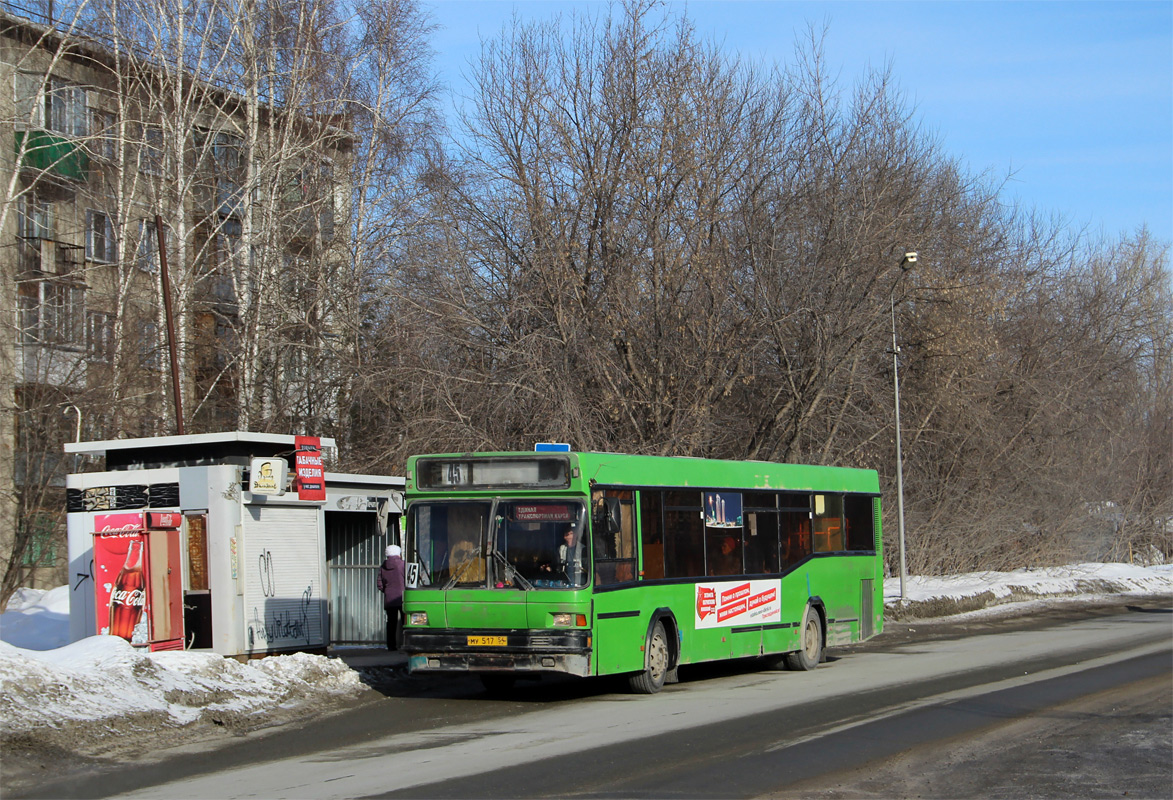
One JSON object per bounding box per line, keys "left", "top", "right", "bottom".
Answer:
{"left": 381, "top": 2, "right": 1169, "bottom": 571}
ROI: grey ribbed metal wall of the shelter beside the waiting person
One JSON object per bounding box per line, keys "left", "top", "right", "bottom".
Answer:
{"left": 326, "top": 511, "right": 391, "bottom": 645}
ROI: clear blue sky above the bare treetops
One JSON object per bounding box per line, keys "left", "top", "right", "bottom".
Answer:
{"left": 422, "top": 0, "right": 1173, "bottom": 243}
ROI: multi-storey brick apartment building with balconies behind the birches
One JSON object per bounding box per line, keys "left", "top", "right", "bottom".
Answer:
{"left": 0, "top": 12, "right": 351, "bottom": 590}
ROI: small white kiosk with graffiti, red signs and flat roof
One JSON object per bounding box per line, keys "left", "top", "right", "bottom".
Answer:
{"left": 66, "top": 432, "right": 404, "bottom": 657}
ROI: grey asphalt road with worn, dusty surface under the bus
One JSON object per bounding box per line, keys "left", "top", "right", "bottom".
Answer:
{"left": 18, "top": 603, "right": 1173, "bottom": 799}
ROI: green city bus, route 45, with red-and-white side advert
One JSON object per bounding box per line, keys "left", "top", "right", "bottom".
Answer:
{"left": 402, "top": 448, "right": 883, "bottom": 693}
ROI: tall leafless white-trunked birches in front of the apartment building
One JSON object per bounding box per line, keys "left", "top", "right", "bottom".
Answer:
{"left": 0, "top": 0, "right": 435, "bottom": 591}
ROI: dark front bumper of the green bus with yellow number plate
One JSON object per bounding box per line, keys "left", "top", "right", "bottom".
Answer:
{"left": 401, "top": 628, "right": 592, "bottom": 677}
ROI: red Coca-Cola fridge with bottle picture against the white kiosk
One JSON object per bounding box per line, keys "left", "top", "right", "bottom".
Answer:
{"left": 94, "top": 511, "right": 183, "bottom": 650}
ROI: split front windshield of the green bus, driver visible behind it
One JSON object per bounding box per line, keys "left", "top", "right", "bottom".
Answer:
{"left": 408, "top": 500, "right": 590, "bottom": 590}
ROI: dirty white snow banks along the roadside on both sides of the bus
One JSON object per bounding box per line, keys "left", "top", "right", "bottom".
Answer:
{"left": 0, "top": 564, "right": 1173, "bottom": 745}
